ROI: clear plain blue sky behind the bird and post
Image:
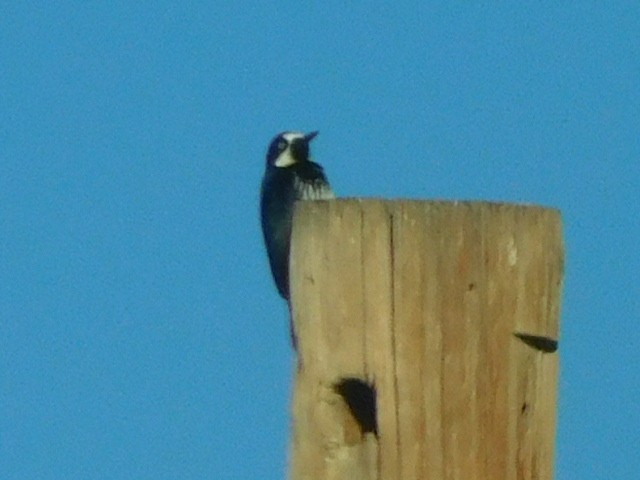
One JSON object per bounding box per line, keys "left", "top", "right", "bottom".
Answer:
{"left": 0, "top": 1, "right": 640, "bottom": 480}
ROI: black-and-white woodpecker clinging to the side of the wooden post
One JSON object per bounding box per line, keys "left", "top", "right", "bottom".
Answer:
{"left": 260, "top": 131, "right": 335, "bottom": 347}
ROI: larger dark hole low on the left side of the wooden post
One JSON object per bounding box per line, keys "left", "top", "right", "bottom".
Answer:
{"left": 333, "top": 378, "right": 378, "bottom": 436}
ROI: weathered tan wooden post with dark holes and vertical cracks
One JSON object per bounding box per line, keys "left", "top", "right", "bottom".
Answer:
{"left": 290, "top": 199, "right": 563, "bottom": 480}
